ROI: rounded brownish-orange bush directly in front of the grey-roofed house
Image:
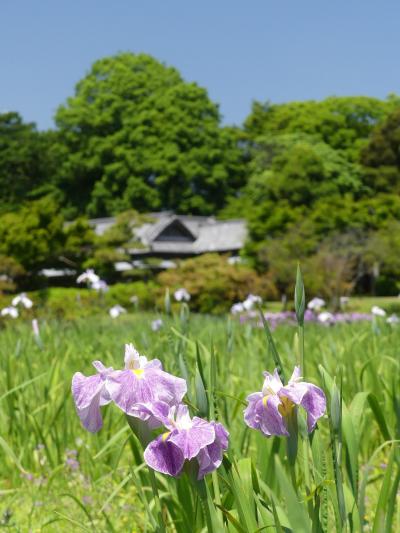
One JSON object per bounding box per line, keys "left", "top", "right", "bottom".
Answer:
{"left": 157, "top": 254, "right": 278, "bottom": 314}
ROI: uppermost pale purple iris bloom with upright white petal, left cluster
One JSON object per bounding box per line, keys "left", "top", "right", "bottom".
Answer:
{"left": 107, "top": 344, "right": 187, "bottom": 427}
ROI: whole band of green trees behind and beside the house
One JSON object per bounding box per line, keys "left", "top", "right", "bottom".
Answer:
{"left": 0, "top": 53, "right": 400, "bottom": 293}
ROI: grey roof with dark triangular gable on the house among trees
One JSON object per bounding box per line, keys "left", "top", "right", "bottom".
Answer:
{"left": 89, "top": 211, "right": 247, "bottom": 255}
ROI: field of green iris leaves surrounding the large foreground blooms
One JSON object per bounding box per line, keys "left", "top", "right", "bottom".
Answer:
{"left": 0, "top": 298, "right": 400, "bottom": 533}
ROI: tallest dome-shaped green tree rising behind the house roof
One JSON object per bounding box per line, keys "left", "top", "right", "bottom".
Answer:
{"left": 56, "top": 53, "right": 244, "bottom": 216}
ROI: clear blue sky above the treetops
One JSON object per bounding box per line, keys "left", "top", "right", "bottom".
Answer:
{"left": 0, "top": 0, "right": 400, "bottom": 129}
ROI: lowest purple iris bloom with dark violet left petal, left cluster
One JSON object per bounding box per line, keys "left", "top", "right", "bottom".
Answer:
{"left": 144, "top": 402, "right": 229, "bottom": 479}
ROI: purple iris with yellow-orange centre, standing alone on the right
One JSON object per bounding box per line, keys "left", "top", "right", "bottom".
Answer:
{"left": 244, "top": 366, "right": 326, "bottom": 437}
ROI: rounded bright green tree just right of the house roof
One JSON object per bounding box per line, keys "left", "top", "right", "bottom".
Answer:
{"left": 228, "top": 134, "right": 363, "bottom": 242}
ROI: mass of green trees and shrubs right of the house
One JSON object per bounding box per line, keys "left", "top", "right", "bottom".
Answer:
{"left": 236, "top": 97, "right": 400, "bottom": 299}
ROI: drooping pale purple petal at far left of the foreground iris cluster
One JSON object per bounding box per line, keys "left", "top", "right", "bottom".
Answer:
{"left": 72, "top": 361, "right": 113, "bottom": 433}
